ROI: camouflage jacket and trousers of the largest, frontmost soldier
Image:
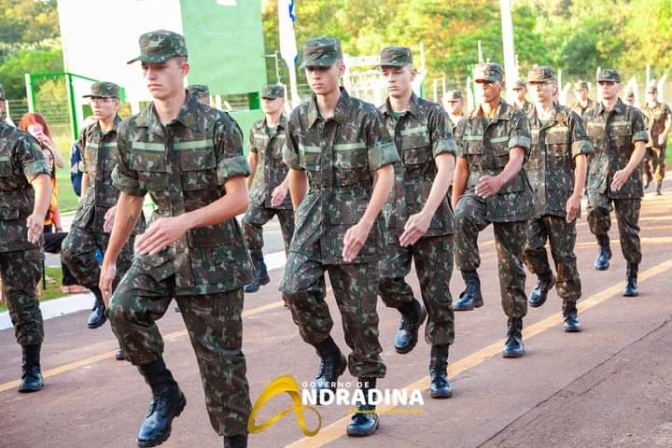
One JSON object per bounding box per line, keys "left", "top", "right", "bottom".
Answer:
{"left": 108, "top": 92, "right": 252, "bottom": 435}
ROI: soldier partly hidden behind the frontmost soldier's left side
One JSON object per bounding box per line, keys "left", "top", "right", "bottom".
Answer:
{"left": 61, "top": 82, "right": 144, "bottom": 360}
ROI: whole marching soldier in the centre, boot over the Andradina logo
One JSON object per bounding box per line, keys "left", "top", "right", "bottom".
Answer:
{"left": 280, "top": 37, "right": 399, "bottom": 436}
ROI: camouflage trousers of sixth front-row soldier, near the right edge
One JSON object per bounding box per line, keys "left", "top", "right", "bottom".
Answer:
{"left": 588, "top": 192, "right": 642, "bottom": 264}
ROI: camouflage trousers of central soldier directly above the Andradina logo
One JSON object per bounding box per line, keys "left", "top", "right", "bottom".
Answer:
{"left": 280, "top": 252, "right": 386, "bottom": 378}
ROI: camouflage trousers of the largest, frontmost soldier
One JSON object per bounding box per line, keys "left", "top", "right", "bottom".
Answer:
{"left": 108, "top": 262, "right": 252, "bottom": 435}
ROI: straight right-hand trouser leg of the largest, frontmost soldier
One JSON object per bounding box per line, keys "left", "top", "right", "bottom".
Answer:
{"left": 177, "top": 288, "right": 252, "bottom": 437}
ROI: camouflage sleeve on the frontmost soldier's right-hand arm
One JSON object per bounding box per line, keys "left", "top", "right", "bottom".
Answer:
{"left": 213, "top": 115, "right": 250, "bottom": 185}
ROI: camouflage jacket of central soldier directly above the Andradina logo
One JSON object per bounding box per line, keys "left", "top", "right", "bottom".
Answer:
{"left": 283, "top": 88, "right": 399, "bottom": 264}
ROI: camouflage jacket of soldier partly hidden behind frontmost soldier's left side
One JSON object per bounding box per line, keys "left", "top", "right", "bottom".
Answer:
{"left": 72, "top": 115, "right": 145, "bottom": 234}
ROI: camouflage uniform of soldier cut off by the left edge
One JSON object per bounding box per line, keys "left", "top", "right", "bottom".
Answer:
{"left": 0, "top": 120, "right": 50, "bottom": 347}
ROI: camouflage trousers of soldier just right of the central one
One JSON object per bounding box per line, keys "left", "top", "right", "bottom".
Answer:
{"left": 378, "top": 235, "right": 455, "bottom": 345}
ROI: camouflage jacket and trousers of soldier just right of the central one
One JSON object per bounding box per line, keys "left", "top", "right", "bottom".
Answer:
{"left": 378, "top": 94, "right": 455, "bottom": 345}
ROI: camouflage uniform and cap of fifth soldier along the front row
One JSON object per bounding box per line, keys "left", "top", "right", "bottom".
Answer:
{"left": 524, "top": 68, "right": 592, "bottom": 303}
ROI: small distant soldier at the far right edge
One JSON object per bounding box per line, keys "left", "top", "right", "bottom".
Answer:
{"left": 642, "top": 81, "right": 672, "bottom": 195}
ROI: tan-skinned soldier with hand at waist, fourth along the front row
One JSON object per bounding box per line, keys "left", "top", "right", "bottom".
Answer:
{"left": 453, "top": 63, "right": 536, "bottom": 358}
